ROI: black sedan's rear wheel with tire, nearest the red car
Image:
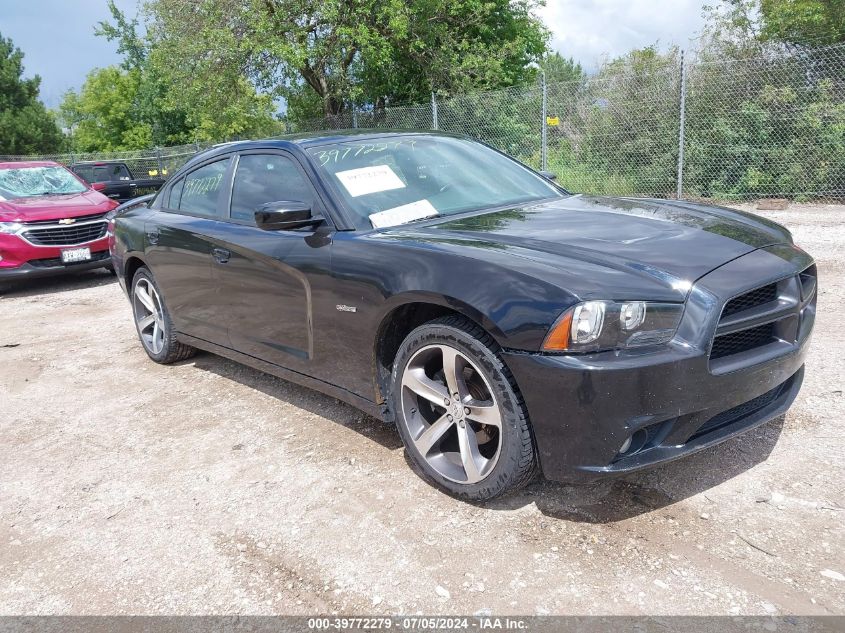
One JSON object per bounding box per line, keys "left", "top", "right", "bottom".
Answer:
{"left": 131, "top": 266, "right": 197, "bottom": 365}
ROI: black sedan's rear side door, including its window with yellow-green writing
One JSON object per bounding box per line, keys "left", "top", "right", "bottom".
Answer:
{"left": 145, "top": 156, "right": 232, "bottom": 347}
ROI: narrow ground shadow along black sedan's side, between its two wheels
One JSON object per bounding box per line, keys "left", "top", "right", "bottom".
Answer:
{"left": 186, "top": 352, "right": 402, "bottom": 451}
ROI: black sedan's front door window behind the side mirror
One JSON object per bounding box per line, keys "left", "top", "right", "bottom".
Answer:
{"left": 231, "top": 154, "right": 314, "bottom": 222}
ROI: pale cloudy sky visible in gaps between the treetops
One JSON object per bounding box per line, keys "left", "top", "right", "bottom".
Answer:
{"left": 0, "top": 0, "right": 703, "bottom": 107}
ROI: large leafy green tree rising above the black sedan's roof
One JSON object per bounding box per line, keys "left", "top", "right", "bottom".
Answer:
{"left": 142, "top": 0, "right": 547, "bottom": 116}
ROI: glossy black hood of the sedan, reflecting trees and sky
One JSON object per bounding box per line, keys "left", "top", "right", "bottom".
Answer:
{"left": 396, "top": 195, "right": 792, "bottom": 285}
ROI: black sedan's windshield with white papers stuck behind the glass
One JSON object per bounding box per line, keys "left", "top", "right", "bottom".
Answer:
{"left": 308, "top": 135, "right": 565, "bottom": 228}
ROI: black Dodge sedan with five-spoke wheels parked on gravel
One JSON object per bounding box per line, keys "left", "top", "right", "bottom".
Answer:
{"left": 111, "top": 132, "right": 816, "bottom": 499}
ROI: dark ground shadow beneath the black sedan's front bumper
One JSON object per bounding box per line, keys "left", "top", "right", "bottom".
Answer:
{"left": 477, "top": 416, "right": 785, "bottom": 523}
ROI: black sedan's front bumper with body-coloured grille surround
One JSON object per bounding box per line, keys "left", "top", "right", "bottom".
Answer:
{"left": 505, "top": 248, "right": 814, "bottom": 483}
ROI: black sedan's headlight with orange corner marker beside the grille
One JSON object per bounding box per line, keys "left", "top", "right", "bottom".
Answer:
{"left": 543, "top": 301, "right": 684, "bottom": 352}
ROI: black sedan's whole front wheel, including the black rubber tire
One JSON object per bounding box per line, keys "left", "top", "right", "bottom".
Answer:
{"left": 389, "top": 316, "right": 538, "bottom": 501}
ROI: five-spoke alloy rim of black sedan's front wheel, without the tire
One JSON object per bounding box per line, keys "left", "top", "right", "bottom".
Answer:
{"left": 402, "top": 345, "right": 502, "bottom": 484}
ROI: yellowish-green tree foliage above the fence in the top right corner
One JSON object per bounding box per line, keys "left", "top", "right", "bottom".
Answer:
{"left": 760, "top": 0, "right": 845, "bottom": 46}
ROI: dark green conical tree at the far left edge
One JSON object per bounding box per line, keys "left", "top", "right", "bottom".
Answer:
{"left": 0, "top": 34, "right": 62, "bottom": 154}
